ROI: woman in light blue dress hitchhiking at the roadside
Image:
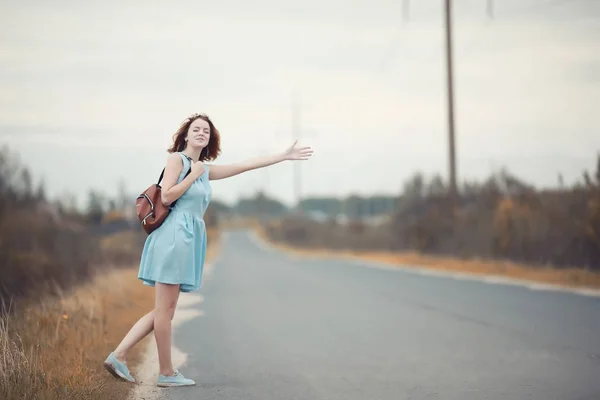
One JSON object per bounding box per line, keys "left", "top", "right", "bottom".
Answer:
{"left": 104, "top": 114, "right": 312, "bottom": 387}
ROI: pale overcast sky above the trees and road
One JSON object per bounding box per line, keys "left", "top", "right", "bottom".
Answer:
{"left": 0, "top": 0, "right": 600, "bottom": 209}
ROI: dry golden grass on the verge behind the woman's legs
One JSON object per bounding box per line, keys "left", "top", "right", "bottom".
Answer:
{"left": 0, "top": 228, "right": 219, "bottom": 400}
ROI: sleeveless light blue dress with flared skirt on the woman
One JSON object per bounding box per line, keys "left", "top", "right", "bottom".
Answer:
{"left": 138, "top": 153, "right": 212, "bottom": 292}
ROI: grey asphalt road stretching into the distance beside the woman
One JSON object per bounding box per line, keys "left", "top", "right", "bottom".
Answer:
{"left": 160, "top": 232, "right": 600, "bottom": 400}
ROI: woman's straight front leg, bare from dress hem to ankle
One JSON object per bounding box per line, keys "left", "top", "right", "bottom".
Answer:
{"left": 154, "top": 282, "right": 179, "bottom": 375}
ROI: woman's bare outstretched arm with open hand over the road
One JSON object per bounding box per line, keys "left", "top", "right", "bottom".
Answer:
{"left": 208, "top": 140, "right": 312, "bottom": 180}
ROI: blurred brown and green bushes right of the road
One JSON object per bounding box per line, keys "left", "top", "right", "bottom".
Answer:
{"left": 267, "top": 154, "right": 600, "bottom": 270}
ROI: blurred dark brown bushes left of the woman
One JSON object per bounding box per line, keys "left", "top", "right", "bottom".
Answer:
{"left": 0, "top": 146, "right": 143, "bottom": 303}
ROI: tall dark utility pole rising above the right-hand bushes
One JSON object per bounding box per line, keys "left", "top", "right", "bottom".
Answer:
{"left": 445, "top": 0, "right": 457, "bottom": 202}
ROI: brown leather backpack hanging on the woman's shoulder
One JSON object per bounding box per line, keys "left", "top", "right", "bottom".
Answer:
{"left": 135, "top": 156, "right": 192, "bottom": 234}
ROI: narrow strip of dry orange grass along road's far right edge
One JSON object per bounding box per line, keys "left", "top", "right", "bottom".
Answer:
{"left": 255, "top": 228, "right": 600, "bottom": 289}
